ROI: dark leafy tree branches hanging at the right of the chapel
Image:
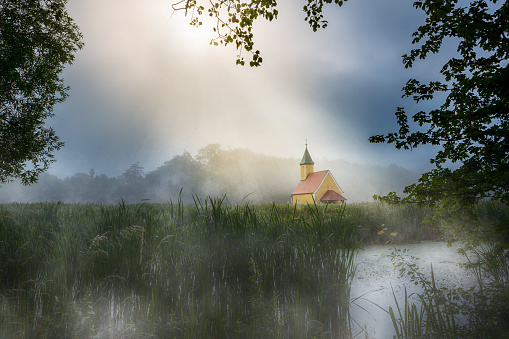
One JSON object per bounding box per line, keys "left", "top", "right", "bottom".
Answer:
{"left": 370, "top": 0, "right": 509, "bottom": 206}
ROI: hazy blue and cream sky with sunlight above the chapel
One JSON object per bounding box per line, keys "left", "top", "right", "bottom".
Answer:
{"left": 49, "top": 0, "right": 452, "bottom": 176}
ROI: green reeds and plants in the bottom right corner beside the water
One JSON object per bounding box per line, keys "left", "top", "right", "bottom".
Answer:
{"left": 388, "top": 244, "right": 509, "bottom": 339}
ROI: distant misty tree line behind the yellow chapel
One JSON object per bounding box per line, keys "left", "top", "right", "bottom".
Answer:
{"left": 0, "top": 144, "right": 418, "bottom": 204}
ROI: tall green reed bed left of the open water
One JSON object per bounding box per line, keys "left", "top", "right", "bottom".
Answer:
{"left": 0, "top": 198, "right": 357, "bottom": 338}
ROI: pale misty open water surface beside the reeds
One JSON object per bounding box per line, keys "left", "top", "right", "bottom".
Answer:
{"left": 350, "top": 241, "right": 475, "bottom": 338}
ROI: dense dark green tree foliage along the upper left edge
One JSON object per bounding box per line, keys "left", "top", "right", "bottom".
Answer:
{"left": 0, "top": 0, "right": 83, "bottom": 184}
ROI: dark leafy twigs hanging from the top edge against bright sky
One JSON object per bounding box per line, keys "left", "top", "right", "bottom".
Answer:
{"left": 172, "top": 0, "right": 344, "bottom": 67}
